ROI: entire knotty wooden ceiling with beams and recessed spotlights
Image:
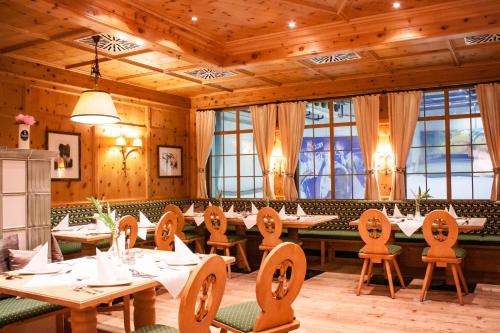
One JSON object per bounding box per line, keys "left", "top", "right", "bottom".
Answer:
{"left": 0, "top": 0, "right": 500, "bottom": 97}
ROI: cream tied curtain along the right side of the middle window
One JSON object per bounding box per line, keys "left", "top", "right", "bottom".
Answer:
{"left": 354, "top": 95, "right": 380, "bottom": 200}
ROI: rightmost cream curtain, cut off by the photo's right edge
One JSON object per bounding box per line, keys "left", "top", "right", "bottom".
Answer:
{"left": 476, "top": 83, "right": 500, "bottom": 201}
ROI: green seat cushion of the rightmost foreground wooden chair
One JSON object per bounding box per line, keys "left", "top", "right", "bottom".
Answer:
{"left": 215, "top": 301, "right": 261, "bottom": 332}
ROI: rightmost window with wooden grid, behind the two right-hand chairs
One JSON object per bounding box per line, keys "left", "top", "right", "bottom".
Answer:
{"left": 406, "top": 89, "right": 493, "bottom": 199}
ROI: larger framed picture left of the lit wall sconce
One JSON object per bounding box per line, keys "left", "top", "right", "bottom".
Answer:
{"left": 46, "top": 131, "right": 80, "bottom": 180}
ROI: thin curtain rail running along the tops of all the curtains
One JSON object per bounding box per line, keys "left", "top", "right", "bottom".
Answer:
{"left": 196, "top": 80, "right": 500, "bottom": 111}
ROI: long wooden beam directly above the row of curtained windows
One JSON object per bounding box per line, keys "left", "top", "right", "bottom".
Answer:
{"left": 191, "top": 61, "right": 500, "bottom": 109}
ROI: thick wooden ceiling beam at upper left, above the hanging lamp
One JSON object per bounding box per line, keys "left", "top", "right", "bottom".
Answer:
{"left": 7, "top": 0, "right": 222, "bottom": 66}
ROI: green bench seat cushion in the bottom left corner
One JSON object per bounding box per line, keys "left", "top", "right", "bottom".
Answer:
{"left": 0, "top": 297, "right": 63, "bottom": 327}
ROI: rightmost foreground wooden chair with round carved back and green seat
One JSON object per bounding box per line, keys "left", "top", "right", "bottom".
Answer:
{"left": 212, "top": 243, "right": 307, "bottom": 333}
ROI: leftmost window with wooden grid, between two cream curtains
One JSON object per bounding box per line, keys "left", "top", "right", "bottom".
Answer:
{"left": 210, "top": 110, "right": 262, "bottom": 198}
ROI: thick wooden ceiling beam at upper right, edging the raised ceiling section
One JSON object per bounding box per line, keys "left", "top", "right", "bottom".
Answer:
{"left": 224, "top": 0, "right": 500, "bottom": 68}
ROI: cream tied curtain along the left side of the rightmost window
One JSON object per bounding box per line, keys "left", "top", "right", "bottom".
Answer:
{"left": 387, "top": 91, "right": 422, "bottom": 200}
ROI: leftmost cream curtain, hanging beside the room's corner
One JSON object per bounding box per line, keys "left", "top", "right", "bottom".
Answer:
{"left": 195, "top": 110, "right": 215, "bottom": 198}
